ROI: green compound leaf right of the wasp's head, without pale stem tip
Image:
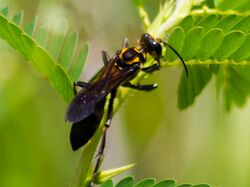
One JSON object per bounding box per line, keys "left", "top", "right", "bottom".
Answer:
{"left": 165, "top": 12, "right": 250, "bottom": 110}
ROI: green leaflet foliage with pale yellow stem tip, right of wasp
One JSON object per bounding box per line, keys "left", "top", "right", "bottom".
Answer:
{"left": 131, "top": 0, "right": 250, "bottom": 111}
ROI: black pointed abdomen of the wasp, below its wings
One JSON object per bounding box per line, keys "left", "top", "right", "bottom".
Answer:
{"left": 70, "top": 98, "right": 106, "bottom": 151}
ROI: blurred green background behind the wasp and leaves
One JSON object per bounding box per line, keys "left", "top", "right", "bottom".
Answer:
{"left": 0, "top": 0, "right": 250, "bottom": 187}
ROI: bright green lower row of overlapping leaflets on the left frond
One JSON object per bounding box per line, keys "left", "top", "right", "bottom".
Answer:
{"left": 0, "top": 11, "right": 73, "bottom": 102}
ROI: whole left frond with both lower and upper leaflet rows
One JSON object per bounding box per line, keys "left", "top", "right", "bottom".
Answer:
{"left": 0, "top": 7, "right": 88, "bottom": 102}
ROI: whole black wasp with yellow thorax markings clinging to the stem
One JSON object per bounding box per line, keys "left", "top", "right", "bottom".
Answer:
{"left": 65, "top": 34, "right": 188, "bottom": 183}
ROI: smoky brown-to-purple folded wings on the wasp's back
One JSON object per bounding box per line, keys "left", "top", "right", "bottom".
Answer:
{"left": 65, "top": 53, "right": 136, "bottom": 123}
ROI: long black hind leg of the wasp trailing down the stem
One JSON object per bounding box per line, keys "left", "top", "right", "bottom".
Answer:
{"left": 90, "top": 89, "right": 117, "bottom": 186}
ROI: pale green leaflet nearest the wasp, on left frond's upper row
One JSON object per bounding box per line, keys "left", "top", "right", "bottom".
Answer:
{"left": 69, "top": 44, "right": 89, "bottom": 80}
